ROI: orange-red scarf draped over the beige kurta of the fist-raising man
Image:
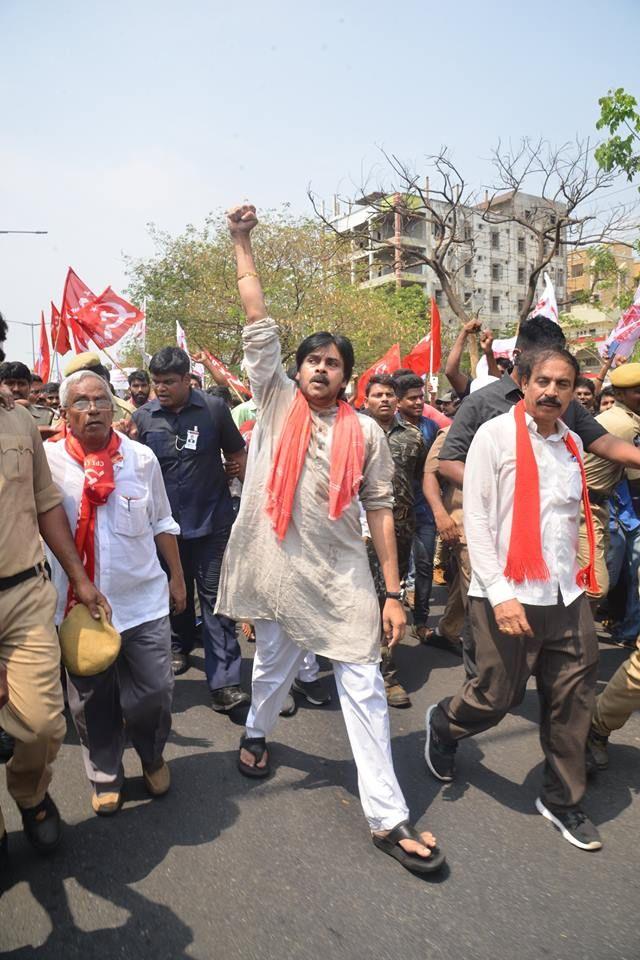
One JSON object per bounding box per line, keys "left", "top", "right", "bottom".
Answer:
{"left": 267, "top": 390, "right": 364, "bottom": 540}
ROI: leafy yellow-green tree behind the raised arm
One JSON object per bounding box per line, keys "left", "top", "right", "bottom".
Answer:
{"left": 125, "top": 206, "right": 438, "bottom": 371}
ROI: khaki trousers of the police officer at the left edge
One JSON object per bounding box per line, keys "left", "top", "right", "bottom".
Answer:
{"left": 0, "top": 576, "right": 66, "bottom": 835}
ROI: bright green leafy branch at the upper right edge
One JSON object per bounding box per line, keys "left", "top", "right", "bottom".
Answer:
{"left": 595, "top": 87, "right": 640, "bottom": 189}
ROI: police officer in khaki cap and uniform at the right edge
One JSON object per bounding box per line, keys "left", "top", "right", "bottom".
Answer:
{"left": 578, "top": 363, "right": 640, "bottom": 600}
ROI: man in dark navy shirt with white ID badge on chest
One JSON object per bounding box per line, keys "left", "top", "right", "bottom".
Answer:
{"left": 133, "top": 347, "right": 249, "bottom": 713}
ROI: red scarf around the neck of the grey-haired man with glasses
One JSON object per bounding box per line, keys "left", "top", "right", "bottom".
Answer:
{"left": 64, "top": 430, "right": 122, "bottom": 610}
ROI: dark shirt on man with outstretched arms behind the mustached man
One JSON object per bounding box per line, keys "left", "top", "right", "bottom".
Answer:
{"left": 439, "top": 373, "right": 607, "bottom": 463}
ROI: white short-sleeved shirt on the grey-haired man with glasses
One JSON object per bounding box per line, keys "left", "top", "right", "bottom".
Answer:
{"left": 44, "top": 433, "right": 180, "bottom": 633}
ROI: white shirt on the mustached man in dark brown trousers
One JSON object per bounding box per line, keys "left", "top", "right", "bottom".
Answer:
{"left": 463, "top": 407, "right": 583, "bottom": 607}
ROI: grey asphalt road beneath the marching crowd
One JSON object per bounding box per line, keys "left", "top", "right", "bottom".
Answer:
{"left": 0, "top": 592, "right": 640, "bottom": 960}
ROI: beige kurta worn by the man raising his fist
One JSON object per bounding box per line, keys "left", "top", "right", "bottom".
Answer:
{"left": 216, "top": 318, "right": 393, "bottom": 663}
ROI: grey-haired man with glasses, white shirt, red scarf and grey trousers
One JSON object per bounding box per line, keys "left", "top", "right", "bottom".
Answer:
{"left": 45, "top": 371, "right": 186, "bottom": 816}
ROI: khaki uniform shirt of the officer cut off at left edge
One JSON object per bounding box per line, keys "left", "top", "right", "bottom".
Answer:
{"left": 0, "top": 406, "right": 62, "bottom": 577}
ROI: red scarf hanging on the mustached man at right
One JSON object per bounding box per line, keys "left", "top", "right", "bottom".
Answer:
{"left": 504, "top": 400, "right": 599, "bottom": 593}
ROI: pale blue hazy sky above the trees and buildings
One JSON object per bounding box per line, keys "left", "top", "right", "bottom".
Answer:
{"left": 0, "top": 0, "right": 640, "bottom": 362}
